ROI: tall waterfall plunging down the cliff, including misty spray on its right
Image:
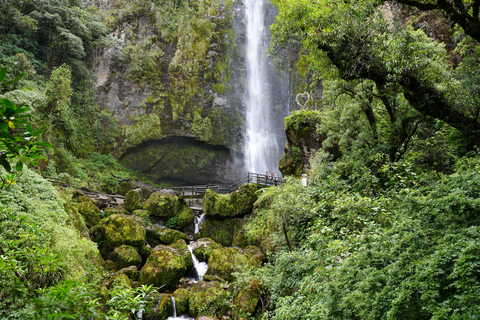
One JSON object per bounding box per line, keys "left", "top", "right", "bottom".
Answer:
{"left": 245, "top": 0, "right": 288, "bottom": 173}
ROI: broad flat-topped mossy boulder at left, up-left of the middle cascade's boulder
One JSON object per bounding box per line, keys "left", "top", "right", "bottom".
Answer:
{"left": 100, "top": 214, "right": 145, "bottom": 249}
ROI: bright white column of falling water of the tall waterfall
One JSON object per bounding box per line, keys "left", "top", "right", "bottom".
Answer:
{"left": 245, "top": 0, "right": 279, "bottom": 173}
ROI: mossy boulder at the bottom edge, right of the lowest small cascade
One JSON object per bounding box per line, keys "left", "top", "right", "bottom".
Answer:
{"left": 188, "top": 281, "right": 230, "bottom": 318}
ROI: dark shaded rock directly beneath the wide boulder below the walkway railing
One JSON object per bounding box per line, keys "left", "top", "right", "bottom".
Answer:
{"left": 195, "top": 218, "right": 245, "bottom": 247}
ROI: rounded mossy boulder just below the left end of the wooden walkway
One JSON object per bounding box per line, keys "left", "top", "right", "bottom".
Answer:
{"left": 143, "top": 191, "right": 185, "bottom": 219}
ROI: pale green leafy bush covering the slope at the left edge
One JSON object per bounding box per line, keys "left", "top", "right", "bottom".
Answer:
{"left": 0, "top": 168, "right": 103, "bottom": 280}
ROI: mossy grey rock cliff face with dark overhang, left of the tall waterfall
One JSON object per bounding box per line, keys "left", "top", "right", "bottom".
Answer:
{"left": 85, "top": 0, "right": 251, "bottom": 184}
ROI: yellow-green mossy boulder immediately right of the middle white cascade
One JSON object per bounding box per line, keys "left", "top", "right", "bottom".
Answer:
{"left": 206, "top": 246, "right": 263, "bottom": 282}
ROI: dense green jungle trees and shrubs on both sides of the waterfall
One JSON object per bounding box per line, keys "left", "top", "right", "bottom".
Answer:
{"left": 0, "top": 0, "right": 480, "bottom": 320}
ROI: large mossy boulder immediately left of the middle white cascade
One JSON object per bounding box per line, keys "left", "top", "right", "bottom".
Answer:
{"left": 140, "top": 240, "right": 193, "bottom": 288}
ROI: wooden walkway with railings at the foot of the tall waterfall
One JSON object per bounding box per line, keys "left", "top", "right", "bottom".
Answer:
{"left": 168, "top": 173, "right": 285, "bottom": 199}
